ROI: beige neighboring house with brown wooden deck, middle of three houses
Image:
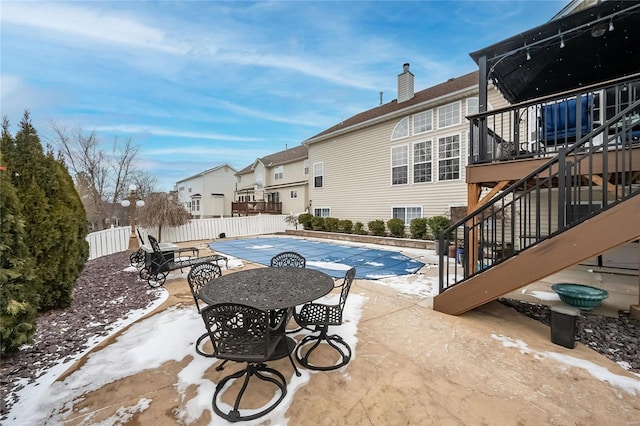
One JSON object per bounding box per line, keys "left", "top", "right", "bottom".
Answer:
{"left": 232, "top": 145, "right": 309, "bottom": 215}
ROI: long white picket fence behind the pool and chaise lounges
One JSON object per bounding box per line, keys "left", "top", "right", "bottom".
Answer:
{"left": 87, "top": 215, "right": 290, "bottom": 259}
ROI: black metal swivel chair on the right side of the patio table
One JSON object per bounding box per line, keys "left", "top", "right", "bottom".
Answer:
{"left": 293, "top": 267, "right": 356, "bottom": 371}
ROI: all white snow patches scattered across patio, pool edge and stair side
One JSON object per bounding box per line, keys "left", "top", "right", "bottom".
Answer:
{"left": 6, "top": 236, "right": 640, "bottom": 426}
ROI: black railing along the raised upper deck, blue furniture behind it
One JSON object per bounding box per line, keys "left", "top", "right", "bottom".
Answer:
{"left": 468, "top": 73, "right": 640, "bottom": 164}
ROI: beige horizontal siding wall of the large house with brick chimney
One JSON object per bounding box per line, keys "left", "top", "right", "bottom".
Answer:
{"left": 309, "top": 93, "right": 477, "bottom": 228}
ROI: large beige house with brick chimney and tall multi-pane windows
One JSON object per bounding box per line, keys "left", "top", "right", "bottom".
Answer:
{"left": 304, "top": 64, "right": 505, "bottom": 226}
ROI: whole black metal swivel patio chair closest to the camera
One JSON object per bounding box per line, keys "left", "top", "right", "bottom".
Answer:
{"left": 202, "top": 303, "right": 300, "bottom": 422}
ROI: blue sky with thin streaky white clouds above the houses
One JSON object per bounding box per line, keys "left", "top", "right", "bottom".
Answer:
{"left": 0, "top": 0, "right": 567, "bottom": 190}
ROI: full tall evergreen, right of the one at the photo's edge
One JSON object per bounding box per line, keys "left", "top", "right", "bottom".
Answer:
{"left": 13, "top": 112, "right": 88, "bottom": 312}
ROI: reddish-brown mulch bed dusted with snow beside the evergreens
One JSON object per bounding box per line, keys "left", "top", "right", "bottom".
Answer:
{"left": 0, "top": 252, "right": 161, "bottom": 420}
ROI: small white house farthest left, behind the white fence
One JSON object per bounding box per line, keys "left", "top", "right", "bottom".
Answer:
{"left": 176, "top": 164, "right": 237, "bottom": 219}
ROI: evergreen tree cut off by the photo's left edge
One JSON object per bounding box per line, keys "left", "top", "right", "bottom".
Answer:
{"left": 0, "top": 145, "right": 38, "bottom": 355}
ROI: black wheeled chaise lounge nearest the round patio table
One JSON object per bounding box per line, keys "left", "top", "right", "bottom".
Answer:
{"left": 140, "top": 235, "right": 229, "bottom": 287}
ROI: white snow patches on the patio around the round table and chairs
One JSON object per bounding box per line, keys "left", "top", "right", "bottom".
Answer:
{"left": 6, "top": 294, "right": 365, "bottom": 425}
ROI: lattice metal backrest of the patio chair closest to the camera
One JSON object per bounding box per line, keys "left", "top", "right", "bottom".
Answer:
{"left": 201, "top": 303, "right": 280, "bottom": 362}
